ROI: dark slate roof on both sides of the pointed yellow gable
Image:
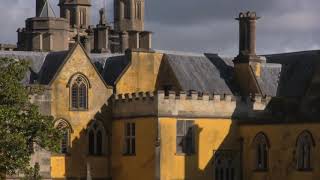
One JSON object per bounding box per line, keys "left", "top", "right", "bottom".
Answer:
{"left": 0, "top": 51, "right": 129, "bottom": 86}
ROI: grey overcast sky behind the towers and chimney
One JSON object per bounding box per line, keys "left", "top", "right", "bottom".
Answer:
{"left": 0, "top": 0, "right": 320, "bottom": 55}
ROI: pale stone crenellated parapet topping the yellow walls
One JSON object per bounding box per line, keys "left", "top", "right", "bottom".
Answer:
{"left": 112, "top": 91, "right": 271, "bottom": 118}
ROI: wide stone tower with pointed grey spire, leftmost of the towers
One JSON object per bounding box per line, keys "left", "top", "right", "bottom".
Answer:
{"left": 17, "top": 0, "right": 69, "bottom": 51}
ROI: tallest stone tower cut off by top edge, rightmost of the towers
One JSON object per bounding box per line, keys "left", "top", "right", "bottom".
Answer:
{"left": 114, "top": 0, "right": 145, "bottom": 32}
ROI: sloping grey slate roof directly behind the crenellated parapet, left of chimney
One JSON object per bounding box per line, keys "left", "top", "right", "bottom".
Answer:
{"left": 165, "top": 54, "right": 233, "bottom": 94}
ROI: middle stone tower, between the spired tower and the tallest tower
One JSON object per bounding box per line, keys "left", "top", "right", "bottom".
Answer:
{"left": 58, "top": 0, "right": 91, "bottom": 29}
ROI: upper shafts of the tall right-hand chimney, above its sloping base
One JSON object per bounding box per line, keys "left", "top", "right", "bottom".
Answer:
{"left": 235, "top": 11, "right": 260, "bottom": 62}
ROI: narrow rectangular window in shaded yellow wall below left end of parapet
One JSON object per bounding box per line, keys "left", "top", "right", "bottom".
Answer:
{"left": 124, "top": 123, "right": 136, "bottom": 155}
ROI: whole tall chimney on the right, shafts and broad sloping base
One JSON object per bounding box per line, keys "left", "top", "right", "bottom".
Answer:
{"left": 233, "top": 11, "right": 263, "bottom": 95}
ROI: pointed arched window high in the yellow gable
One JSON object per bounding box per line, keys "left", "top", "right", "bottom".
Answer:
{"left": 70, "top": 75, "right": 89, "bottom": 110}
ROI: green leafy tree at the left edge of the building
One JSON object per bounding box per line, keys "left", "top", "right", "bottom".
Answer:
{"left": 0, "top": 58, "right": 62, "bottom": 179}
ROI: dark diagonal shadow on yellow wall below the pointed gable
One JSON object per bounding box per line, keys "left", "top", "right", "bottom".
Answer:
{"left": 62, "top": 105, "right": 111, "bottom": 180}
